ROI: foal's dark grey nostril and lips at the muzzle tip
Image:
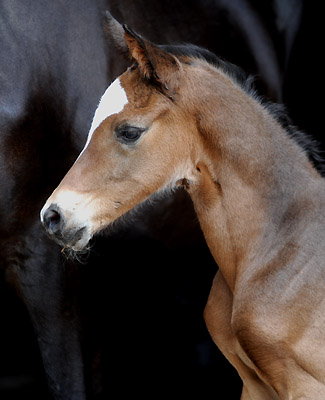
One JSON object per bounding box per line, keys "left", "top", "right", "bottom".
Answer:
{"left": 41, "top": 204, "right": 89, "bottom": 250}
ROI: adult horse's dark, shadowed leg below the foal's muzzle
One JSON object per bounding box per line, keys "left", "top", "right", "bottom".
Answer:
{"left": 1, "top": 222, "right": 86, "bottom": 400}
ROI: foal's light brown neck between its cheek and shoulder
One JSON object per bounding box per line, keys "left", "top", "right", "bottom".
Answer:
{"left": 189, "top": 77, "right": 323, "bottom": 290}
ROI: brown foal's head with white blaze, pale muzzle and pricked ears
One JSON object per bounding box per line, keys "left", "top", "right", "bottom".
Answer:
{"left": 41, "top": 14, "right": 233, "bottom": 250}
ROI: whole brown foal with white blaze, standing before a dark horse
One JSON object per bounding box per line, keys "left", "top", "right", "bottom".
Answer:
{"left": 41, "top": 14, "right": 325, "bottom": 400}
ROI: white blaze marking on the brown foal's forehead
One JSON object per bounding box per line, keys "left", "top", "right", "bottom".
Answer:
{"left": 78, "top": 79, "right": 128, "bottom": 158}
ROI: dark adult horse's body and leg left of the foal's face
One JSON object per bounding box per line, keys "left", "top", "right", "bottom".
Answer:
{"left": 0, "top": 0, "right": 108, "bottom": 399}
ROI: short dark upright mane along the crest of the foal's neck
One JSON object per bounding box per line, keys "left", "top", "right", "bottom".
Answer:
{"left": 160, "top": 44, "right": 325, "bottom": 177}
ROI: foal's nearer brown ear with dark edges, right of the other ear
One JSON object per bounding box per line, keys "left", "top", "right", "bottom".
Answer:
{"left": 123, "top": 25, "right": 180, "bottom": 98}
